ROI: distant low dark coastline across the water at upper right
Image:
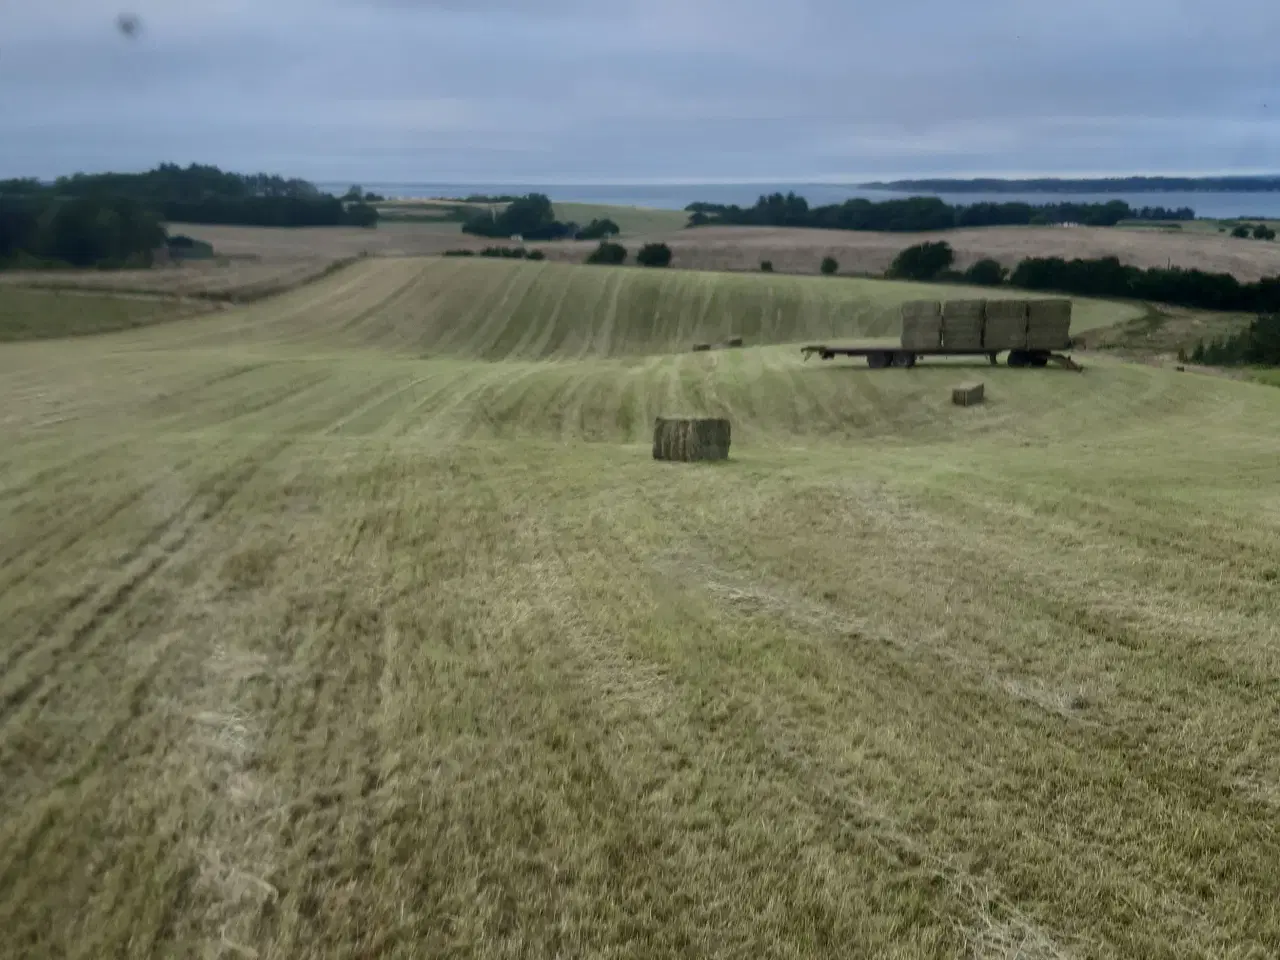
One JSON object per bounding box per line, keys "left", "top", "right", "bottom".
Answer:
{"left": 858, "top": 174, "right": 1280, "bottom": 193}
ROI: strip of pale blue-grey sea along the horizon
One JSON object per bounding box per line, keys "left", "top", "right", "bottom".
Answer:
{"left": 317, "top": 183, "right": 1280, "bottom": 220}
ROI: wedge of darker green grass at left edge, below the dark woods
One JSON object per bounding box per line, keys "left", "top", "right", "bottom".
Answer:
{"left": 0, "top": 287, "right": 207, "bottom": 342}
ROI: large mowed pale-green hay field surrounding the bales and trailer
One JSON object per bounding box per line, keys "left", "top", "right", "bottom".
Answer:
{"left": 0, "top": 259, "right": 1280, "bottom": 960}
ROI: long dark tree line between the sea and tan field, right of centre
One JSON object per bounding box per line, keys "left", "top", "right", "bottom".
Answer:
{"left": 685, "top": 193, "right": 1167, "bottom": 233}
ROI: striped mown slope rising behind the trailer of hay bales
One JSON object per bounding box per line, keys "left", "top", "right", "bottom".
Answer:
{"left": 132, "top": 259, "right": 1142, "bottom": 360}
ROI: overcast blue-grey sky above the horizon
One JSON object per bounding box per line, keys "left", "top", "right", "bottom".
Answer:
{"left": 0, "top": 0, "right": 1280, "bottom": 183}
